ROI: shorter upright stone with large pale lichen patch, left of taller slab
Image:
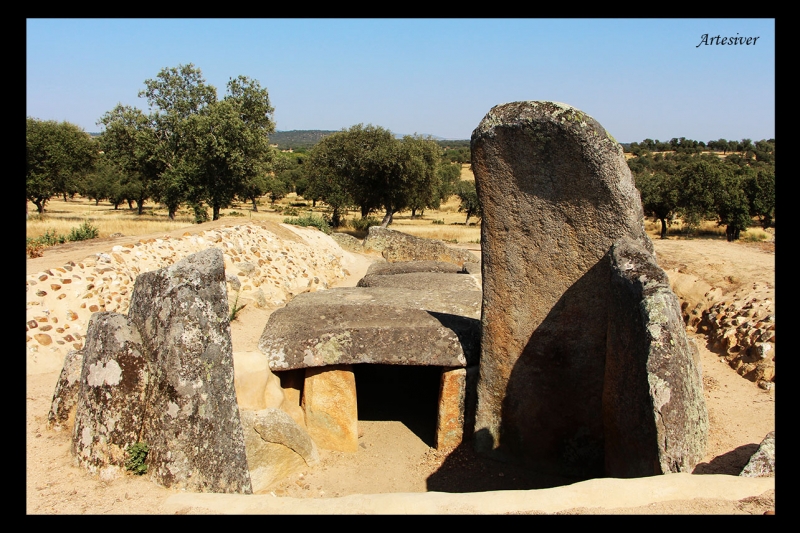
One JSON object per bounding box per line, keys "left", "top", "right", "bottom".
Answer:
{"left": 72, "top": 312, "right": 149, "bottom": 478}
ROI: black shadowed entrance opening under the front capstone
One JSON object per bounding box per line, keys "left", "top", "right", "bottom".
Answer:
{"left": 353, "top": 364, "right": 442, "bottom": 447}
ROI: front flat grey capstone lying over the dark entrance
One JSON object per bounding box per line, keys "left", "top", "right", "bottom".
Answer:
{"left": 258, "top": 286, "right": 481, "bottom": 371}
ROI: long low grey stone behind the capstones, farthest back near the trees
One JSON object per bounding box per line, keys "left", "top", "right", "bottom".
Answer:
{"left": 363, "top": 226, "right": 479, "bottom": 266}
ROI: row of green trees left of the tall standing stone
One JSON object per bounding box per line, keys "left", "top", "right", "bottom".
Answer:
{"left": 26, "top": 64, "right": 477, "bottom": 226}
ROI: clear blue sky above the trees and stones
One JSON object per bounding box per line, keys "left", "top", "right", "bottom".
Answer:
{"left": 26, "top": 18, "right": 775, "bottom": 142}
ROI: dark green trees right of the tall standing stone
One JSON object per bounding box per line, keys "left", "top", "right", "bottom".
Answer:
{"left": 628, "top": 138, "right": 776, "bottom": 241}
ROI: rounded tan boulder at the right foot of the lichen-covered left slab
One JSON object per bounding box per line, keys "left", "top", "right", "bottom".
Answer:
{"left": 239, "top": 408, "right": 319, "bottom": 493}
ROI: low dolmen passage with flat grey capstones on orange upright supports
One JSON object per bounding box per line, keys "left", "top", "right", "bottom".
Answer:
{"left": 258, "top": 260, "right": 481, "bottom": 452}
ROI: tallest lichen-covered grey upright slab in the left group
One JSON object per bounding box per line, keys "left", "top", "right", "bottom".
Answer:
{"left": 129, "top": 248, "right": 252, "bottom": 493}
